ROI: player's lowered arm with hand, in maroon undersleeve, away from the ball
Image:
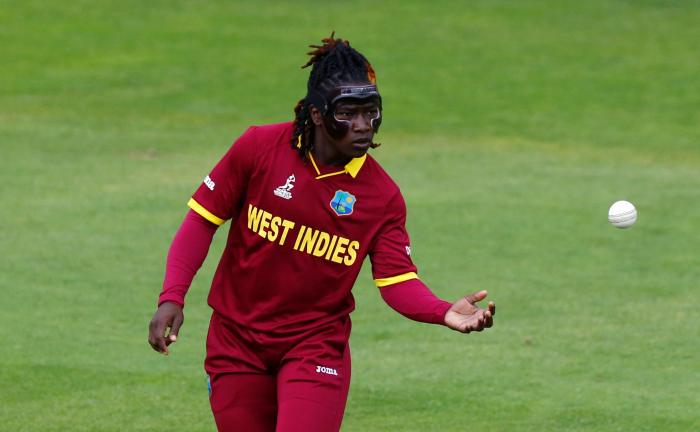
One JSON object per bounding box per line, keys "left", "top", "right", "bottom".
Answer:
{"left": 148, "top": 210, "right": 218, "bottom": 354}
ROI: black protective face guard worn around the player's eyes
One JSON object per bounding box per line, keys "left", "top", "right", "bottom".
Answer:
{"left": 306, "top": 84, "right": 382, "bottom": 139}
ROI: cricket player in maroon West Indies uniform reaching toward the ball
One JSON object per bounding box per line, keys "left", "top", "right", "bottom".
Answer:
{"left": 149, "top": 35, "right": 495, "bottom": 432}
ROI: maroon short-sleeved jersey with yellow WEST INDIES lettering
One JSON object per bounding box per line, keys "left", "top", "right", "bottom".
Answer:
{"left": 188, "top": 123, "right": 417, "bottom": 333}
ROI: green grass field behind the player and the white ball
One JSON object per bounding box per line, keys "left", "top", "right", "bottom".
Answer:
{"left": 0, "top": 0, "right": 700, "bottom": 431}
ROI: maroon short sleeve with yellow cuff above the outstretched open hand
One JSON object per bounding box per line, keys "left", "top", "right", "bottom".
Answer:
{"left": 369, "top": 192, "right": 418, "bottom": 288}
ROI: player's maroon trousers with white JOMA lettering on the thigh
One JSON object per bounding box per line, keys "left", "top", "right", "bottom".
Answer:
{"left": 205, "top": 313, "right": 350, "bottom": 432}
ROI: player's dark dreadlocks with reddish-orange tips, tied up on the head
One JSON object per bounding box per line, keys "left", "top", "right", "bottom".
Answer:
{"left": 290, "top": 31, "right": 379, "bottom": 158}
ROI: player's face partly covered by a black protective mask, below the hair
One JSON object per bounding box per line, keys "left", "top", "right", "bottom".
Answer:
{"left": 311, "top": 99, "right": 381, "bottom": 160}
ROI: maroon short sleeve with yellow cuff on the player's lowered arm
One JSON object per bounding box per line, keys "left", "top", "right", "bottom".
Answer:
{"left": 187, "top": 127, "right": 257, "bottom": 225}
